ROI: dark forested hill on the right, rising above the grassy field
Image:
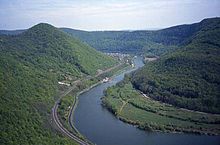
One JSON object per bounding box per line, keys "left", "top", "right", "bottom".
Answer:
{"left": 131, "top": 18, "right": 220, "bottom": 113}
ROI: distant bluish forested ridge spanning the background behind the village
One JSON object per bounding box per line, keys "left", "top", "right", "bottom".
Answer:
{"left": 61, "top": 18, "right": 218, "bottom": 55}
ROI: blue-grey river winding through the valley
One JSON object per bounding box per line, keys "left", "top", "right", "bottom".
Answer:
{"left": 72, "top": 57, "right": 220, "bottom": 145}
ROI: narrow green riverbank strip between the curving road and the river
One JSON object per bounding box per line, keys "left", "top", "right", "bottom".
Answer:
{"left": 55, "top": 59, "right": 130, "bottom": 144}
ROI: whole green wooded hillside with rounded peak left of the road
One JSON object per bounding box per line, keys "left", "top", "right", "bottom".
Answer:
{"left": 0, "top": 23, "right": 117, "bottom": 145}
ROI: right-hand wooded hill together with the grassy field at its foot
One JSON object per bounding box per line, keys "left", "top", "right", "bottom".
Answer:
{"left": 102, "top": 18, "right": 220, "bottom": 135}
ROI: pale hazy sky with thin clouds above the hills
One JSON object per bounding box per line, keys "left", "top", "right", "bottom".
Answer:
{"left": 0, "top": 0, "right": 220, "bottom": 30}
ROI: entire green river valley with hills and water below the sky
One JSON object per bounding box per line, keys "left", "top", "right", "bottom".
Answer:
{"left": 0, "top": 18, "right": 220, "bottom": 145}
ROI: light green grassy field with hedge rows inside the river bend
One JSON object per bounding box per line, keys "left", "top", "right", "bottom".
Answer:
{"left": 103, "top": 83, "right": 220, "bottom": 135}
